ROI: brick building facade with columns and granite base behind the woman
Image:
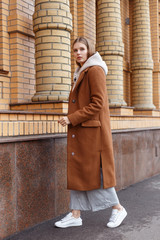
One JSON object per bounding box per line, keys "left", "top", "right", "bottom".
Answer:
{"left": 0, "top": 0, "right": 160, "bottom": 238}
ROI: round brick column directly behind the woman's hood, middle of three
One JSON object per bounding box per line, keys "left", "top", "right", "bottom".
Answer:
{"left": 97, "top": 0, "right": 126, "bottom": 106}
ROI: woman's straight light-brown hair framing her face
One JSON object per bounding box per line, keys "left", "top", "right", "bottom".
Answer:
{"left": 72, "top": 37, "right": 95, "bottom": 67}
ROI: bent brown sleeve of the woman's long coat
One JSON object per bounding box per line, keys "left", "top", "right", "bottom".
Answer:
{"left": 68, "top": 66, "right": 106, "bottom": 126}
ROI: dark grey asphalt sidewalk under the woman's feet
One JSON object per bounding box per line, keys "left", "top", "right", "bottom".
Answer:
{"left": 5, "top": 175, "right": 160, "bottom": 240}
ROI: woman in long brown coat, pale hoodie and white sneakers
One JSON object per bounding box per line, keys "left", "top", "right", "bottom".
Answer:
{"left": 55, "top": 37, "right": 127, "bottom": 228}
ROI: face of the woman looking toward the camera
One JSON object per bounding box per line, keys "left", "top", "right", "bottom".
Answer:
{"left": 73, "top": 42, "right": 88, "bottom": 66}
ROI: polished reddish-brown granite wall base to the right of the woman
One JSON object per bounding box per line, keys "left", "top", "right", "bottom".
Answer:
{"left": 113, "top": 128, "right": 160, "bottom": 190}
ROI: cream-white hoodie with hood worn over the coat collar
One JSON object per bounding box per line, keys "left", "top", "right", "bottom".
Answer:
{"left": 72, "top": 52, "right": 108, "bottom": 91}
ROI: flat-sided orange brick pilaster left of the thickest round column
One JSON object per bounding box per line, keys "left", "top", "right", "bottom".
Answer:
{"left": 8, "top": 0, "right": 35, "bottom": 103}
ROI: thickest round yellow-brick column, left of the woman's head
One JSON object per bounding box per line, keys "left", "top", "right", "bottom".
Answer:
{"left": 32, "top": 0, "right": 72, "bottom": 101}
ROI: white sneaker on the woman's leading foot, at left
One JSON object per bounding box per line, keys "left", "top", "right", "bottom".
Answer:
{"left": 54, "top": 212, "right": 82, "bottom": 228}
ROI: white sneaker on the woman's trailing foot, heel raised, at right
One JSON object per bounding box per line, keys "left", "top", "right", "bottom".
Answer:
{"left": 107, "top": 208, "right": 127, "bottom": 228}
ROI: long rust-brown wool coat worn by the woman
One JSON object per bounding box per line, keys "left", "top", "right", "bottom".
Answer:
{"left": 67, "top": 66, "right": 116, "bottom": 191}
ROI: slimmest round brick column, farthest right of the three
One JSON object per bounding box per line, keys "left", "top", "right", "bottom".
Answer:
{"left": 132, "top": 0, "right": 155, "bottom": 109}
